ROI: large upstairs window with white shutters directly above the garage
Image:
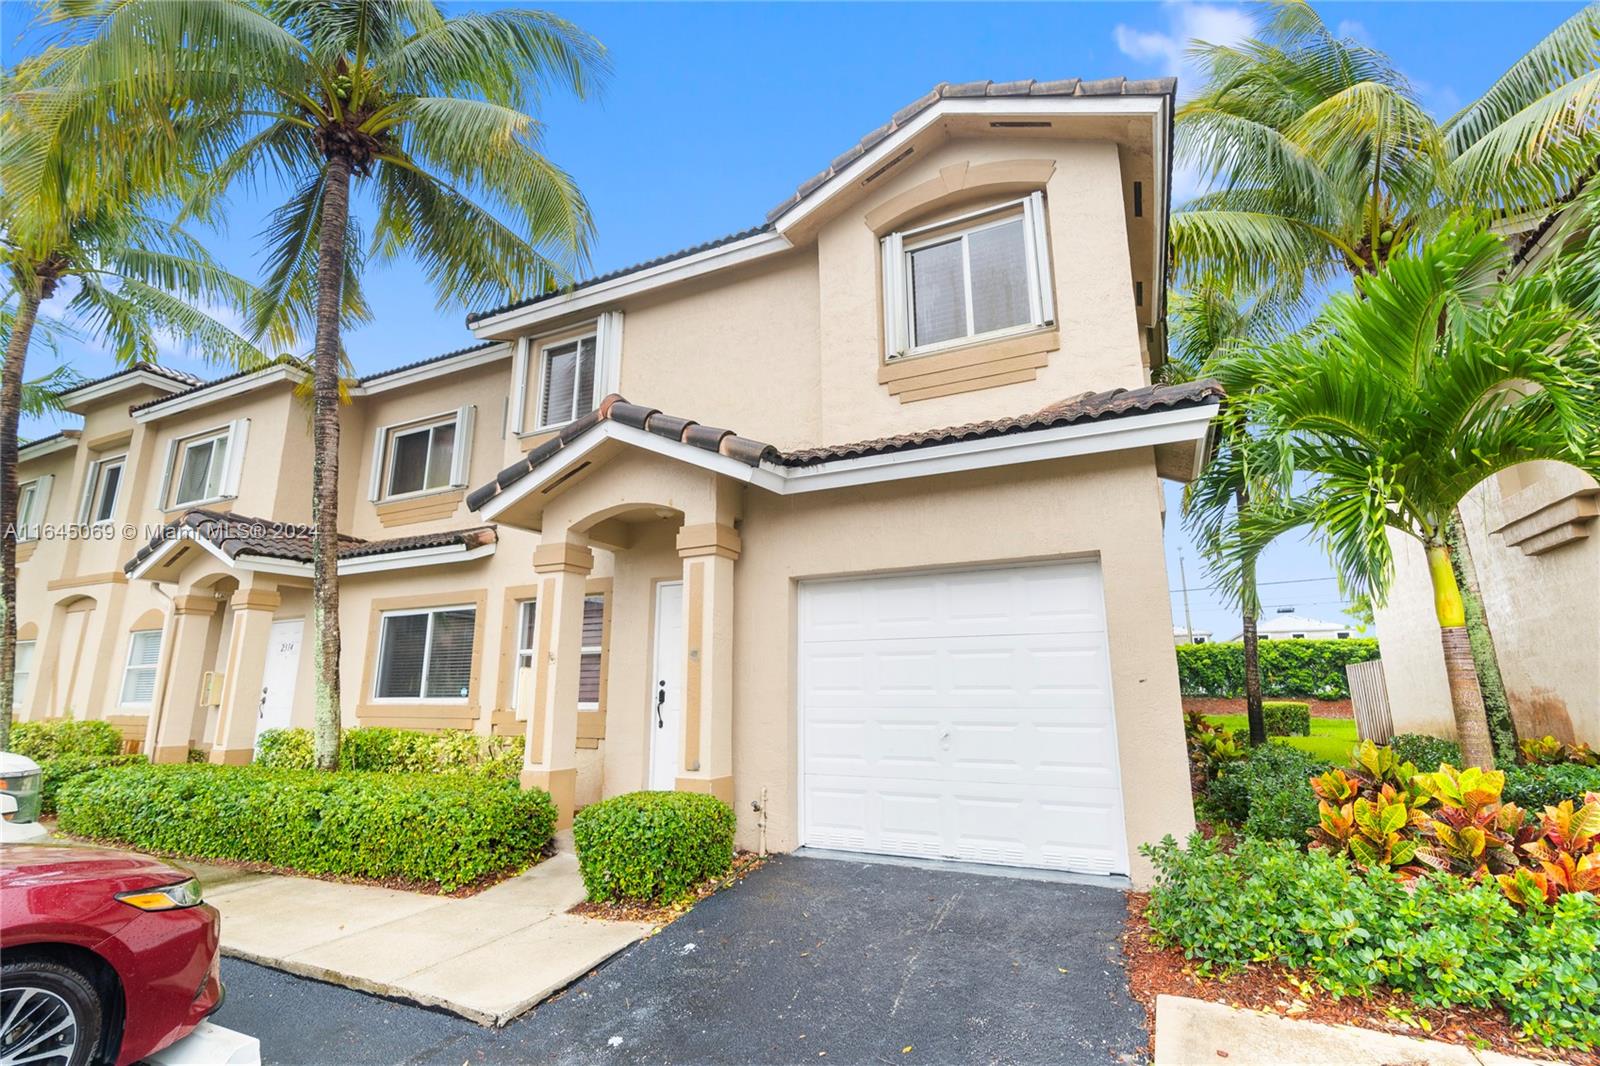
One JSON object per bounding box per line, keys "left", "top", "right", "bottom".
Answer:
{"left": 883, "top": 192, "right": 1056, "bottom": 359}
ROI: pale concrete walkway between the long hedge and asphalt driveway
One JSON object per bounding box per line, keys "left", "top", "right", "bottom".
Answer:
{"left": 184, "top": 832, "right": 651, "bottom": 1026}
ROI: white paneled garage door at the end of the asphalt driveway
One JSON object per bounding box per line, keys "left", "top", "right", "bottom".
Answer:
{"left": 800, "top": 562, "right": 1128, "bottom": 874}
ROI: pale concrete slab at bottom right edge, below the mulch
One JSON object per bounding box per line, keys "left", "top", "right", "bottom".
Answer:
{"left": 1155, "top": 996, "right": 1557, "bottom": 1066}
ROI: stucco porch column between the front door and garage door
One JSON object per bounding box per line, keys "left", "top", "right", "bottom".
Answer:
{"left": 677, "top": 522, "right": 741, "bottom": 804}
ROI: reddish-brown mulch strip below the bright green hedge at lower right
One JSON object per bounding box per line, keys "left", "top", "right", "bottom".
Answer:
{"left": 1122, "top": 892, "right": 1600, "bottom": 1066}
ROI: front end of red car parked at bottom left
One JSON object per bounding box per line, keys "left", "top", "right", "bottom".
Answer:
{"left": 0, "top": 845, "right": 222, "bottom": 1066}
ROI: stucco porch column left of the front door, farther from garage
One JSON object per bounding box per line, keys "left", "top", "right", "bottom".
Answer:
{"left": 522, "top": 539, "right": 595, "bottom": 829}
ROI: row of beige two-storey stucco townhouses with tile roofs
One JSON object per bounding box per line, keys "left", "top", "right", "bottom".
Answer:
{"left": 19, "top": 78, "right": 1221, "bottom": 880}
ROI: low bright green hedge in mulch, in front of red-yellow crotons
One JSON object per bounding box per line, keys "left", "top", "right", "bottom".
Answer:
{"left": 1146, "top": 836, "right": 1600, "bottom": 1048}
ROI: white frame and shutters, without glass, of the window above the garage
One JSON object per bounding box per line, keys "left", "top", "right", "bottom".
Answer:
{"left": 882, "top": 192, "right": 1056, "bottom": 362}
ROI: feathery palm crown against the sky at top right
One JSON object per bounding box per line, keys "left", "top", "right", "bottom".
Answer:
{"left": 1173, "top": 0, "right": 1600, "bottom": 295}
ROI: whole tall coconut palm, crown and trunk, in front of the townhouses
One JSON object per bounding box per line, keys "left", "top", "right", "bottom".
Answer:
{"left": 58, "top": 0, "right": 605, "bottom": 770}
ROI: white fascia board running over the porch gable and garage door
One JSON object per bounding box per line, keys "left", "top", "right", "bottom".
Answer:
{"left": 482, "top": 403, "right": 1219, "bottom": 522}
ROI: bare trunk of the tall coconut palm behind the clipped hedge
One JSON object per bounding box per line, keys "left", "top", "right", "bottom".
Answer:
{"left": 310, "top": 155, "right": 350, "bottom": 770}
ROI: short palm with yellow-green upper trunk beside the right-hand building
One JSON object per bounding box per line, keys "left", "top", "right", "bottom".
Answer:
{"left": 1227, "top": 218, "right": 1600, "bottom": 767}
